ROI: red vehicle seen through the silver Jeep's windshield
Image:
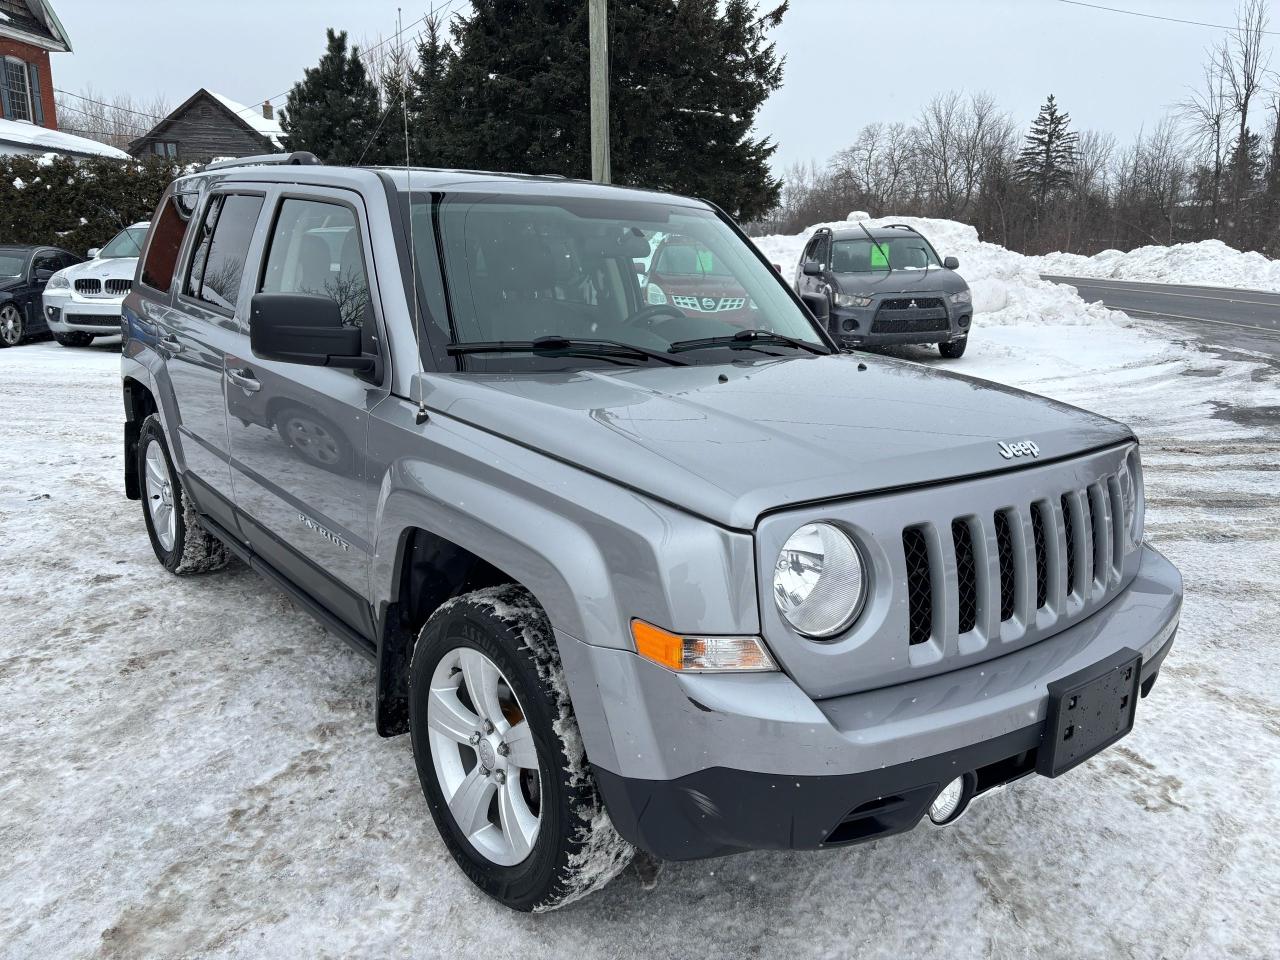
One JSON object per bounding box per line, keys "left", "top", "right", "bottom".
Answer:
{"left": 645, "top": 236, "right": 759, "bottom": 329}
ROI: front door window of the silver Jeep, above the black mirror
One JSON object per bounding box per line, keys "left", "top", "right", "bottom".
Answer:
{"left": 260, "top": 198, "right": 370, "bottom": 326}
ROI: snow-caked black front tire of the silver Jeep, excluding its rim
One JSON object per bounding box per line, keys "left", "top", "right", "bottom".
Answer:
{"left": 410, "top": 584, "right": 635, "bottom": 911}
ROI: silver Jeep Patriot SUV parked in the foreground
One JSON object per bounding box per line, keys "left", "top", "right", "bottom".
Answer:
{"left": 123, "top": 155, "right": 1181, "bottom": 910}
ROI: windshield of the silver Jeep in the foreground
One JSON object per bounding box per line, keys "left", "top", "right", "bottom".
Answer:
{"left": 412, "top": 195, "right": 826, "bottom": 369}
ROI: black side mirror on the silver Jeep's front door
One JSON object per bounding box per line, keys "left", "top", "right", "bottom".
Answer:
{"left": 248, "top": 293, "right": 378, "bottom": 370}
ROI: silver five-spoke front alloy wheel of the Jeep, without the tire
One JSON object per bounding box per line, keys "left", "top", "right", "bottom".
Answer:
{"left": 426, "top": 646, "right": 541, "bottom": 867}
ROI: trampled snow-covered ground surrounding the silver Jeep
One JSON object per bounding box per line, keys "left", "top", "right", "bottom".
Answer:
{"left": 0, "top": 281, "right": 1280, "bottom": 960}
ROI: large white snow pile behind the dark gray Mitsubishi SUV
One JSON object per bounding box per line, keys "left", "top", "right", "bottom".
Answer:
{"left": 754, "top": 212, "right": 1129, "bottom": 326}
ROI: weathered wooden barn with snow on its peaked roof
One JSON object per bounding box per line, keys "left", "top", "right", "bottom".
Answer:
{"left": 129, "top": 90, "right": 284, "bottom": 164}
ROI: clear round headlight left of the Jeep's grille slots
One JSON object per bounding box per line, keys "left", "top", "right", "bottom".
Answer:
{"left": 773, "top": 524, "right": 867, "bottom": 639}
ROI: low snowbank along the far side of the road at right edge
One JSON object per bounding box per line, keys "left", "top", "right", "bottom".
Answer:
{"left": 1030, "top": 239, "right": 1280, "bottom": 292}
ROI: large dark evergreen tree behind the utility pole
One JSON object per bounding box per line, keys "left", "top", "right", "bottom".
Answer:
{"left": 415, "top": 0, "right": 787, "bottom": 219}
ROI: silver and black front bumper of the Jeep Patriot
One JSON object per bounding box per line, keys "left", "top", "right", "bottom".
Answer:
{"left": 576, "top": 547, "right": 1181, "bottom": 860}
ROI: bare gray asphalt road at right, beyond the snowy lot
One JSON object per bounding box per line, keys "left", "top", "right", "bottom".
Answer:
{"left": 1044, "top": 275, "right": 1280, "bottom": 358}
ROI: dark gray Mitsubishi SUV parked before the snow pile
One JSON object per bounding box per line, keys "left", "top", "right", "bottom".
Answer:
{"left": 795, "top": 224, "right": 973, "bottom": 360}
